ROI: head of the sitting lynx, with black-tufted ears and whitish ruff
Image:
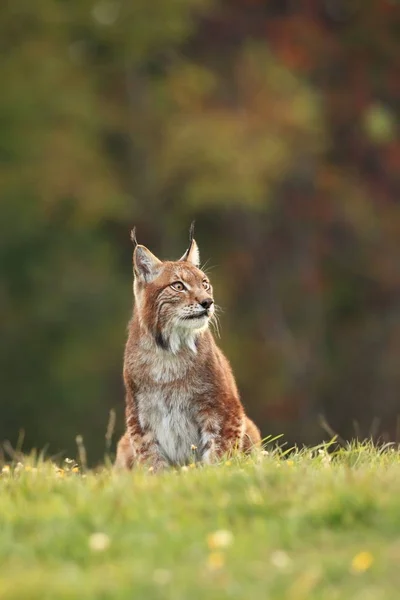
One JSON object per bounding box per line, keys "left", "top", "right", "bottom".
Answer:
{"left": 131, "top": 224, "right": 214, "bottom": 353}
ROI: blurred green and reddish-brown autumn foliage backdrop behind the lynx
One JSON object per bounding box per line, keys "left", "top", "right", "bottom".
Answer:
{"left": 0, "top": 0, "right": 400, "bottom": 463}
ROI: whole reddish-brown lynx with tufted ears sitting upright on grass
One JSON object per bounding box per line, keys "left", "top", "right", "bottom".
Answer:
{"left": 116, "top": 226, "right": 261, "bottom": 471}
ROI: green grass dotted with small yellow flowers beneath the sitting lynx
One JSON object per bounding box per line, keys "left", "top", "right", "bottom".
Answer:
{"left": 0, "top": 445, "right": 400, "bottom": 600}
